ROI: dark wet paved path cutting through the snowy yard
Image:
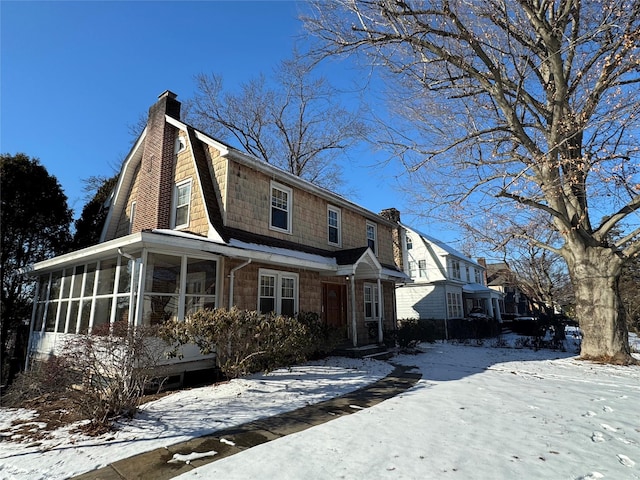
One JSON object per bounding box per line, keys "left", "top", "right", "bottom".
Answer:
{"left": 74, "top": 366, "right": 421, "bottom": 480}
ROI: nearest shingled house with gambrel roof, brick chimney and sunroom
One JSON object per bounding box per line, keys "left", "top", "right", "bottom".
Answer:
{"left": 29, "top": 91, "right": 407, "bottom": 369}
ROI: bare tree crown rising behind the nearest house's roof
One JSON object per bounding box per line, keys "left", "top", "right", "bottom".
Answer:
{"left": 187, "top": 55, "right": 365, "bottom": 190}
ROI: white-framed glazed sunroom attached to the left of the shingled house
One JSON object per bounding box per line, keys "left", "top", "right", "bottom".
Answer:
{"left": 29, "top": 232, "right": 224, "bottom": 374}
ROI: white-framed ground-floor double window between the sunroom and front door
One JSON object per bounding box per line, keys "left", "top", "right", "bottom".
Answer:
{"left": 258, "top": 268, "right": 298, "bottom": 317}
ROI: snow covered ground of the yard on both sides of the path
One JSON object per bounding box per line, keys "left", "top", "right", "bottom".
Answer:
{"left": 0, "top": 336, "right": 640, "bottom": 480}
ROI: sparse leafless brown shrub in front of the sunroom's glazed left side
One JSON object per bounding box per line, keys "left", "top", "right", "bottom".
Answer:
{"left": 3, "top": 322, "right": 165, "bottom": 434}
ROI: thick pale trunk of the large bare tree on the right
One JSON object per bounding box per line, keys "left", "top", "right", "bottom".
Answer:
{"left": 565, "top": 245, "right": 637, "bottom": 365}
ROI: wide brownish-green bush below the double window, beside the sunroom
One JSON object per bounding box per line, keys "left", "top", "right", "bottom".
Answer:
{"left": 160, "top": 307, "right": 331, "bottom": 378}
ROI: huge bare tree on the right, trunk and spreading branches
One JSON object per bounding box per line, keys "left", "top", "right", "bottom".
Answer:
{"left": 304, "top": 0, "right": 640, "bottom": 364}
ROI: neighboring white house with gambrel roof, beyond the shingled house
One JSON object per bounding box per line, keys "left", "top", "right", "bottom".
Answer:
{"left": 396, "top": 224, "right": 502, "bottom": 321}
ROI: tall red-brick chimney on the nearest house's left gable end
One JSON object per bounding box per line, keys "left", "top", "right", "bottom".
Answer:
{"left": 131, "top": 90, "right": 180, "bottom": 233}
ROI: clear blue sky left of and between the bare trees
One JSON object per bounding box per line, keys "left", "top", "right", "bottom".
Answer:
{"left": 0, "top": 0, "right": 456, "bottom": 247}
